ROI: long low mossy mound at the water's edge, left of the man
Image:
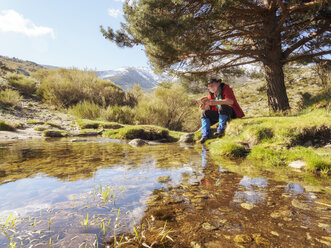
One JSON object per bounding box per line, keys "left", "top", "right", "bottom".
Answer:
{"left": 103, "top": 126, "right": 171, "bottom": 140}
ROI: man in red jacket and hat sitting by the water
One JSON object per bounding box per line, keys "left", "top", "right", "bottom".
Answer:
{"left": 198, "top": 78, "right": 245, "bottom": 144}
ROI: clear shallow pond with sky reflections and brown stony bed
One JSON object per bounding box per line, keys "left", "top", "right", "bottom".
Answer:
{"left": 0, "top": 138, "right": 331, "bottom": 247}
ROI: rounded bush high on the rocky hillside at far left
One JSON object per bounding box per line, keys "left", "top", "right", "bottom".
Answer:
{"left": 7, "top": 74, "right": 37, "bottom": 96}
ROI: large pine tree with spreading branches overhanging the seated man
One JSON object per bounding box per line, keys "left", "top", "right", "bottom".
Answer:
{"left": 101, "top": 0, "right": 331, "bottom": 111}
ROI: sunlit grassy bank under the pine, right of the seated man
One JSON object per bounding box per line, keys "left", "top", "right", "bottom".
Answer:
{"left": 206, "top": 109, "right": 331, "bottom": 174}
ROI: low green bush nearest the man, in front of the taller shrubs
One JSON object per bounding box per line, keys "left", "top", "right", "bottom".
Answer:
{"left": 101, "top": 105, "right": 135, "bottom": 124}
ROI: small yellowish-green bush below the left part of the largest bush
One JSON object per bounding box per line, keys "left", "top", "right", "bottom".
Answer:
{"left": 68, "top": 101, "right": 101, "bottom": 119}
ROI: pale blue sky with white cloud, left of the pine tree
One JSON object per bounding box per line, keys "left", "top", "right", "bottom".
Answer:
{"left": 0, "top": 0, "right": 148, "bottom": 70}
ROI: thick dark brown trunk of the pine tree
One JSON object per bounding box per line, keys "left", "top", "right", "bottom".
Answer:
{"left": 262, "top": 3, "right": 290, "bottom": 112}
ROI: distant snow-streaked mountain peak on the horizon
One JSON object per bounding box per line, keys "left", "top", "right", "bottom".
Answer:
{"left": 97, "top": 67, "right": 169, "bottom": 90}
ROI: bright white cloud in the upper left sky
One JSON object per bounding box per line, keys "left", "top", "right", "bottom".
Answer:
{"left": 0, "top": 9, "right": 55, "bottom": 39}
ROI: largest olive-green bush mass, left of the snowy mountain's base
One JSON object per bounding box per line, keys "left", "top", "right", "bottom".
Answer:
{"left": 34, "top": 69, "right": 125, "bottom": 108}
